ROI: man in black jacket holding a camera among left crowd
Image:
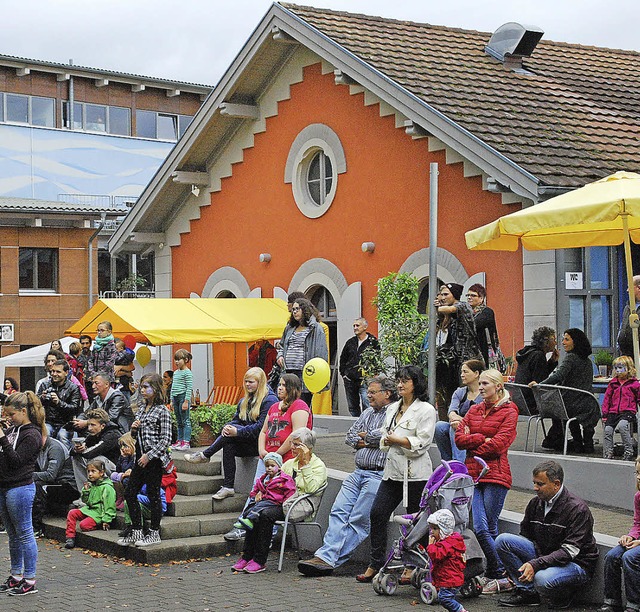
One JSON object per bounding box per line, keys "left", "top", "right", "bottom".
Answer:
{"left": 39, "top": 359, "right": 82, "bottom": 449}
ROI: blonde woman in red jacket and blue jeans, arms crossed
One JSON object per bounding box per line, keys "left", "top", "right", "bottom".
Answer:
{"left": 455, "top": 370, "right": 518, "bottom": 594}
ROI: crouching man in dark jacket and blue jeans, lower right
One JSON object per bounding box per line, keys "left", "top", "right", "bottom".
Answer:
{"left": 496, "top": 461, "right": 598, "bottom": 609}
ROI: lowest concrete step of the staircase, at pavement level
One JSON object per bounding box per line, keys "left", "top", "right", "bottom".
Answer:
{"left": 40, "top": 519, "right": 239, "bottom": 566}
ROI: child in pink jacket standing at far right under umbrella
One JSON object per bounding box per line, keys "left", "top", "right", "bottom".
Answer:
{"left": 602, "top": 355, "right": 640, "bottom": 461}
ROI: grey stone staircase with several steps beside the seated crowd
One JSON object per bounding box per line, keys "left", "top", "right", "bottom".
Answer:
{"left": 44, "top": 452, "right": 246, "bottom": 564}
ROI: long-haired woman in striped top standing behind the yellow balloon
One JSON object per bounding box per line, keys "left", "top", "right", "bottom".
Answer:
{"left": 276, "top": 298, "right": 329, "bottom": 406}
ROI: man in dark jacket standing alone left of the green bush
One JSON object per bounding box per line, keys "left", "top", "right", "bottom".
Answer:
{"left": 339, "top": 317, "right": 380, "bottom": 417}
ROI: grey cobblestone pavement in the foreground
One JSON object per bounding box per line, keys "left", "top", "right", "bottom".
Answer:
{"left": 0, "top": 536, "right": 596, "bottom": 612}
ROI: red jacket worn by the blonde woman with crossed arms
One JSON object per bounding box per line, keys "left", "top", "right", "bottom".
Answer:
{"left": 455, "top": 391, "right": 518, "bottom": 489}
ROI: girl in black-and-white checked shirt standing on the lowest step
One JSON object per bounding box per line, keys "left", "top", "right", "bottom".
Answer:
{"left": 118, "top": 374, "right": 171, "bottom": 546}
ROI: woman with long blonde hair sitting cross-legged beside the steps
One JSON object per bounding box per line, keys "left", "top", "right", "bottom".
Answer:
{"left": 184, "top": 368, "right": 278, "bottom": 500}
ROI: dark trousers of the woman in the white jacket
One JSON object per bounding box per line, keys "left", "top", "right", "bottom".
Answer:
{"left": 369, "top": 480, "right": 426, "bottom": 570}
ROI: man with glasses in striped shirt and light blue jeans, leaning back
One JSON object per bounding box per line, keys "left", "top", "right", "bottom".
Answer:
{"left": 298, "top": 376, "right": 396, "bottom": 576}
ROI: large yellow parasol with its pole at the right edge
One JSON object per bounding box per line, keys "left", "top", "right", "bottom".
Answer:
{"left": 465, "top": 172, "right": 640, "bottom": 371}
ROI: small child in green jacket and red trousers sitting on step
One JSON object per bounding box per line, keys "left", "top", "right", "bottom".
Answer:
{"left": 64, "top": 459, "right": 116, "bottom": 548}
